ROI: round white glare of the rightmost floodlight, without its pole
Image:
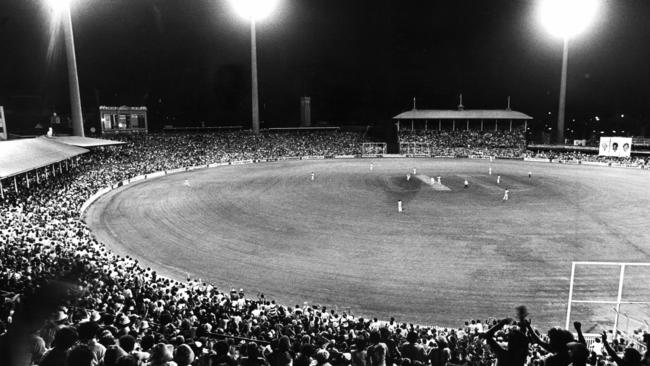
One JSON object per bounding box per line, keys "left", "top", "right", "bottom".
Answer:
{"left": 539, "top": 0, "right": 600, "bottom": 39}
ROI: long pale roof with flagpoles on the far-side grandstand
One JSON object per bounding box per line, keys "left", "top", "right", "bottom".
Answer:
{"left": 393, "top": 109, "right": 533, "bottom": 120}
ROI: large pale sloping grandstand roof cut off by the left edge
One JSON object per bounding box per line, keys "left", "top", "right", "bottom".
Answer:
{"left": 0, "top": 136, "right": 88, "bottom": 179}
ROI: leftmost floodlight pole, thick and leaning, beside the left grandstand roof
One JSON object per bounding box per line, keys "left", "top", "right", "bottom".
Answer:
{"left": 62, "top": 4, "right": 84, "bottom": 137}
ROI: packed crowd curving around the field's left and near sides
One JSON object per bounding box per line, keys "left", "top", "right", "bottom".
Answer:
{"left": 0, "top": 132, "right": 649, "bottom": 366}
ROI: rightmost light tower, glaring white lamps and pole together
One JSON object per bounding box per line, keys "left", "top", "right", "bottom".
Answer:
{"left": 539, "top": 0, "right": 600, "bottom": 144}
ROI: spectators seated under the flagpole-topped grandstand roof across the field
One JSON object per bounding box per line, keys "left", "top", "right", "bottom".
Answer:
{"left": 399, "top": 130, "right": 526, "bottom": 158}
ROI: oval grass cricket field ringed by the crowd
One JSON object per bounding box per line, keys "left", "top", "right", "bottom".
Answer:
{"left": 85, "top": 159, "right": 650, "bottom": 331}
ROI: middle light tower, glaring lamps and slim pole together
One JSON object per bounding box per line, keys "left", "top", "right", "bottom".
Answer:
{"left": 230, "top": 0, "right": 278, "bottom": 134}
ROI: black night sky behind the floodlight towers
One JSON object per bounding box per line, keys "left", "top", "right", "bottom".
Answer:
{"left": 0, "top": 0, "right": 650, "bottom": 130}
